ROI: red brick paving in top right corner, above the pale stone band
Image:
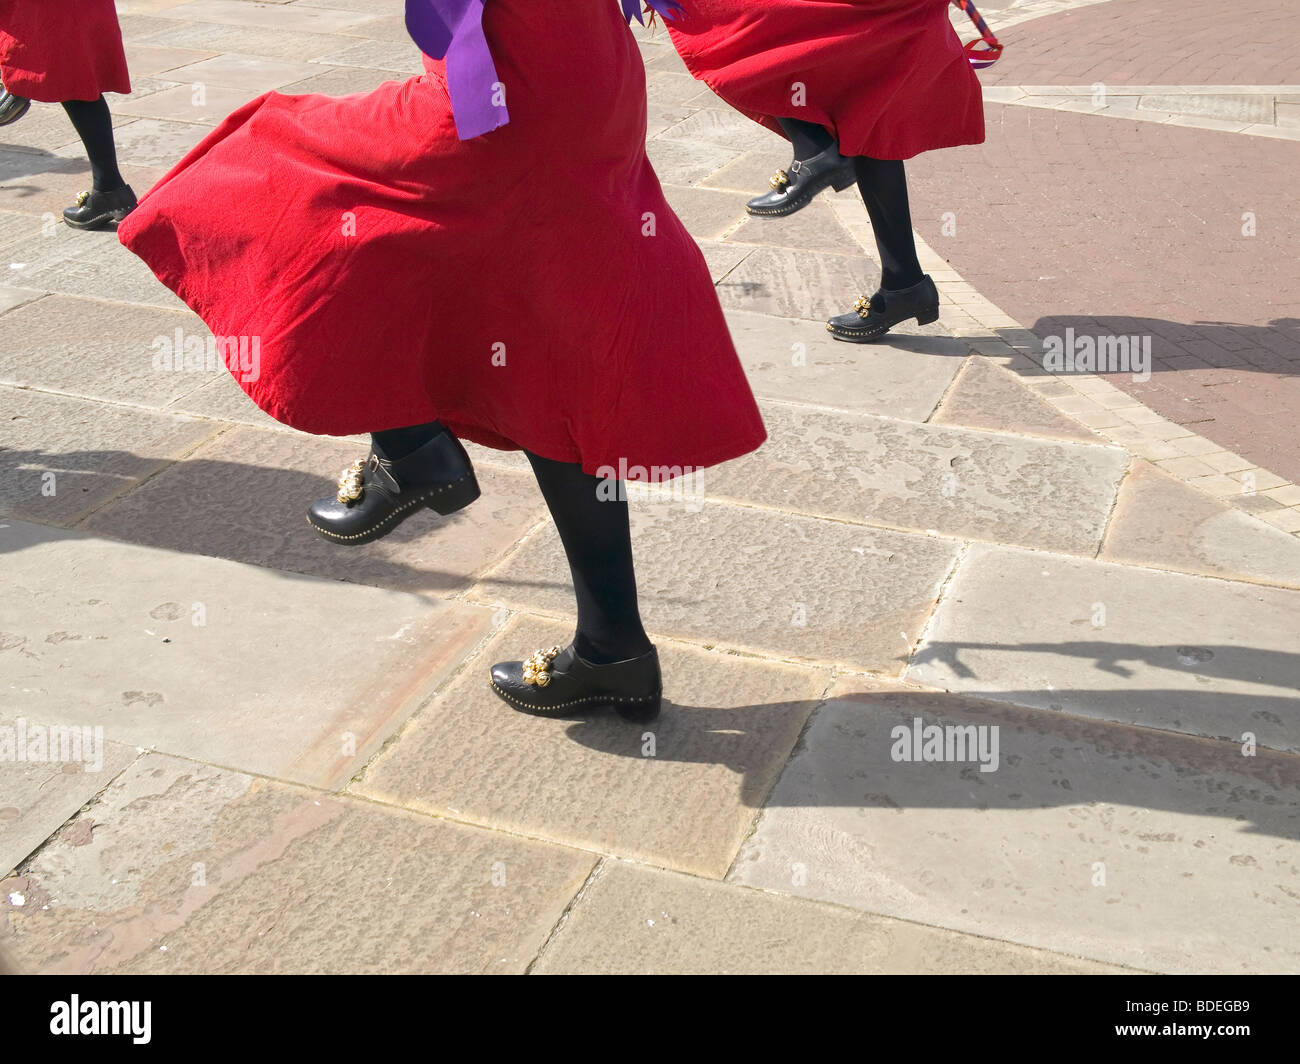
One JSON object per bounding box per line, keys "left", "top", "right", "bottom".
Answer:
{"left": 982, "top": 0, "right": 1300, "bottom": 85}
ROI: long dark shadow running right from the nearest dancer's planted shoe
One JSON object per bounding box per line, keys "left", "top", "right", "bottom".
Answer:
{"left": 568, "top": 691, "right": 1300, "bottom": 839}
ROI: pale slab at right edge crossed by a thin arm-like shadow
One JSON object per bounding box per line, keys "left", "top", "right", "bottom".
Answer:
{"left": 907, "top": 544, "right": 1300, "bottom": 752}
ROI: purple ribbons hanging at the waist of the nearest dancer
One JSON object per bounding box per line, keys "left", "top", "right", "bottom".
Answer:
{"left": 406, "top": 0, "right": 683, "bottom": 140}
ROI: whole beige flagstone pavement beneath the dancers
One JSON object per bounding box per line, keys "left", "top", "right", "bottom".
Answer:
{"left": 0, "top": 0, "right": 1300, "bottom": 973}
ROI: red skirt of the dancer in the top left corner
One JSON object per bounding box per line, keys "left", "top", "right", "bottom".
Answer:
{"left": 0, "top": 0, "right": 131, "bottom": 104}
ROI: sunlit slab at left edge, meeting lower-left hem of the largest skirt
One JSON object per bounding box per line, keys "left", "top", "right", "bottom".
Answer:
{"left": 0, "top": 295, "right": 219, "bottom": 412}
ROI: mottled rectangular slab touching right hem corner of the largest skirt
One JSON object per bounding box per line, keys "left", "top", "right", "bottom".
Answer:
{"left": 706, "top": 402, "right": 1128, "bottom": 546}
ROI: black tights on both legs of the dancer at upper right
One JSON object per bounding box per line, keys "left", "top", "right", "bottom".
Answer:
{"left": 776, "top": 118, "right": 926, "bottom": 291}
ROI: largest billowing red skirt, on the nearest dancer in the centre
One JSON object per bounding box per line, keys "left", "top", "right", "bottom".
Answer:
{"left": 118, "top": 0, "right": 766, "bottom": 479}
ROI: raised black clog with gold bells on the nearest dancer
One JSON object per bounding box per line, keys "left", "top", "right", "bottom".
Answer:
{"left": 307, "top": 432, "right": 478, "bottom": 545}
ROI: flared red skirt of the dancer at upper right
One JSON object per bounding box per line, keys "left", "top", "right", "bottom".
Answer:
{"left": 667, "top": 0, "right": 984, "bottom": 159}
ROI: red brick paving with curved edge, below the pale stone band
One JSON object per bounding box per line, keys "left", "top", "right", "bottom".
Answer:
{"left": 909, "top": 102, "right": 1300, "bottom": 481}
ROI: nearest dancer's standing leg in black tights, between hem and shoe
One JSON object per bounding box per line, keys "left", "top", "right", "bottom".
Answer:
{"left": 525, "top": 451, "right": 651, "bottom": 665}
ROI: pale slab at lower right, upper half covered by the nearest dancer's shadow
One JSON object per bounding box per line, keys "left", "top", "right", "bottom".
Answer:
{"left": 729, "top": 676, "right": 1300, "bottom": 973}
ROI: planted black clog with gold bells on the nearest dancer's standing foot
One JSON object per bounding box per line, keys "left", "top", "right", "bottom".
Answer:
{"left": 491, "top": 644, "right": 663, "bottom": 721}
